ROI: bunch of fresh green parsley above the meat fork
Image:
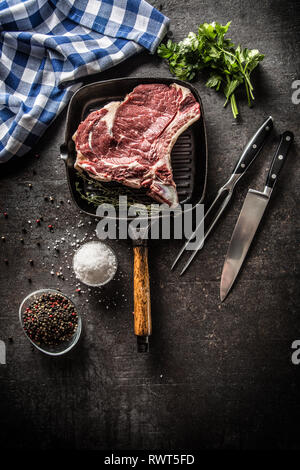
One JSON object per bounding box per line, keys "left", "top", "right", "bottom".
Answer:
{"left": 158, "top": 21, "right": 264, "bottom": 118}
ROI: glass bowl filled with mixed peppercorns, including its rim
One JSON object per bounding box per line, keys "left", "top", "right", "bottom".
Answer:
{"left": 19, "top": 289, "right": 82, "bottom": 356}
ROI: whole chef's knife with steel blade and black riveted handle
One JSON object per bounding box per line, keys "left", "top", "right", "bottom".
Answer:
{"left": 220, "top": 131, "right": 294, "bottom": 302}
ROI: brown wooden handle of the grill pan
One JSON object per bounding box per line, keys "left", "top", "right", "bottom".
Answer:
{"left": 133, "top": 245, "right": 152, "bottom": 352}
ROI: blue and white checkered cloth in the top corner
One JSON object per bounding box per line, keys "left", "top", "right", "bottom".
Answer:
{"left": 0, "top": 0, "right": 169, "bottom": 163}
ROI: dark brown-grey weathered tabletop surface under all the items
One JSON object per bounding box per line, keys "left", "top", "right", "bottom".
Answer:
{"left": 0, "top": 0, "right": 300, "bottom": 449}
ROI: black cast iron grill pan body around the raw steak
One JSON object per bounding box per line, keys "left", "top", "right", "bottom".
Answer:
{"left": 61, "top": 78, "right": 207, "bottom": 216}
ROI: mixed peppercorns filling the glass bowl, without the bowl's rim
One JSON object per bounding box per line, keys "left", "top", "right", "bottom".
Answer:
{"left": 23, "top": 293, "right": 78, "bottom": 345}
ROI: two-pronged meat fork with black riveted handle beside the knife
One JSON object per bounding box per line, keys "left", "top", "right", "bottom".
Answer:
{"left": 171, "top": 116, "right": 273, "bottom": 276}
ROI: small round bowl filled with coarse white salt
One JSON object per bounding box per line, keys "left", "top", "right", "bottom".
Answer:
{"left": 73, "top": 241, "right": 117, "bottom": 287}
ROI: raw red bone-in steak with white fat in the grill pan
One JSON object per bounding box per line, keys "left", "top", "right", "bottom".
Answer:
{"left": 73, "top": 83, "right": 200, "bottom": 207}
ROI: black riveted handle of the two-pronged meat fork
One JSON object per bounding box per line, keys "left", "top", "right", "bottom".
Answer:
{"left": 232, "top": 116, "right": 273, "bottom": 175}
